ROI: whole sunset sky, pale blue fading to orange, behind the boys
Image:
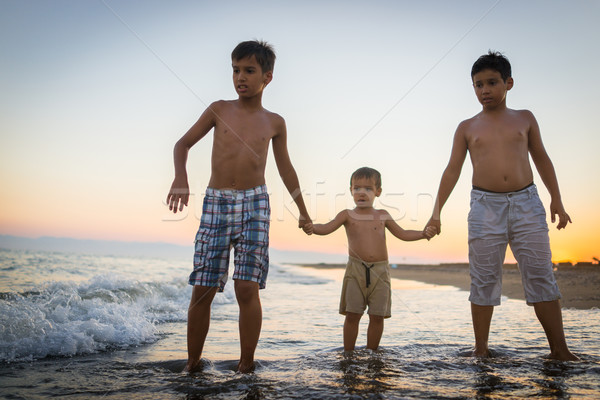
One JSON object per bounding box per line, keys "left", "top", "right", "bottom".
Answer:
{"left": 0, "top": 0, "right": 600, "bottom": 262}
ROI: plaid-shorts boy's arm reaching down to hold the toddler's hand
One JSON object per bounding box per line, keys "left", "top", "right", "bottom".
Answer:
{"left": 273, "top": 116, "right": 311, "bottom": 228}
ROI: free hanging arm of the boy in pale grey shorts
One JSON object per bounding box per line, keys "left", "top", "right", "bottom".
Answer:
{"left": 523, "top": 111, "right": 571, "bottom": 229}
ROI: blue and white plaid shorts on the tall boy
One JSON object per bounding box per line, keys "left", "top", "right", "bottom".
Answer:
{"left": 189, "top": 185, "right": 271, "bottom": 292}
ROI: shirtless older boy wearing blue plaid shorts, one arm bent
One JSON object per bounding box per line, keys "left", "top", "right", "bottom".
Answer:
{"left": 167, "top": 41, "right": 310, "bottom": 373}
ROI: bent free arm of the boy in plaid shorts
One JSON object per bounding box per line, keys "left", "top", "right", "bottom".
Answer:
{"left": 167, "top": 103, "right": 218, "bottom": 213}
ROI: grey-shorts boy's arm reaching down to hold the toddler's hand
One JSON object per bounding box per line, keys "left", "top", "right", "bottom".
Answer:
{"left": 426, "top": 121, "right": 467, "bottom": 235}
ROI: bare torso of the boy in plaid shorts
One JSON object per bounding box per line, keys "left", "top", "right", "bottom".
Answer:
{"left": 208, "top": 100, "right": 283, "bottom": 190}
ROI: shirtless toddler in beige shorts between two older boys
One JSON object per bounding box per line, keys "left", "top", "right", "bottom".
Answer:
{"left": 304, "top": 167, "right": 435, "bottom": 351}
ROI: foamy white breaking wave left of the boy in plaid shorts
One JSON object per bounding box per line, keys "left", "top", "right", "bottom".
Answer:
{"left": 0, "top": 275, "right": 190, "bottom": 362}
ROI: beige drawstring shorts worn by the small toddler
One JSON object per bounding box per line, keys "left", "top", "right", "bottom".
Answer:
{"left": 340, "top": 256, "right": 392, "bottom": 318}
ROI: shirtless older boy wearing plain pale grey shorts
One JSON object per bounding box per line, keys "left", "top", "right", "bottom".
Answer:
{"left": 428, "top": 51, "right": 577, "bottom": 360}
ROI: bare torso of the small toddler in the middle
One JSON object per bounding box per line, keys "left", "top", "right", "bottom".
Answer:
{"left": 344, "top": 208, "right": 389, "bottom": 263}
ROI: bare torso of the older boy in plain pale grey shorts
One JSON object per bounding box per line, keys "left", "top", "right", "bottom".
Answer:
{"left": 459, "top": 109, "right": 533, "bottom": 192}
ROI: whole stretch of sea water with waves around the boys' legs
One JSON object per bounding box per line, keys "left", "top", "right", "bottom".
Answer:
{"left": 0, "top": 250, "right": 600, "bottom": 400}
